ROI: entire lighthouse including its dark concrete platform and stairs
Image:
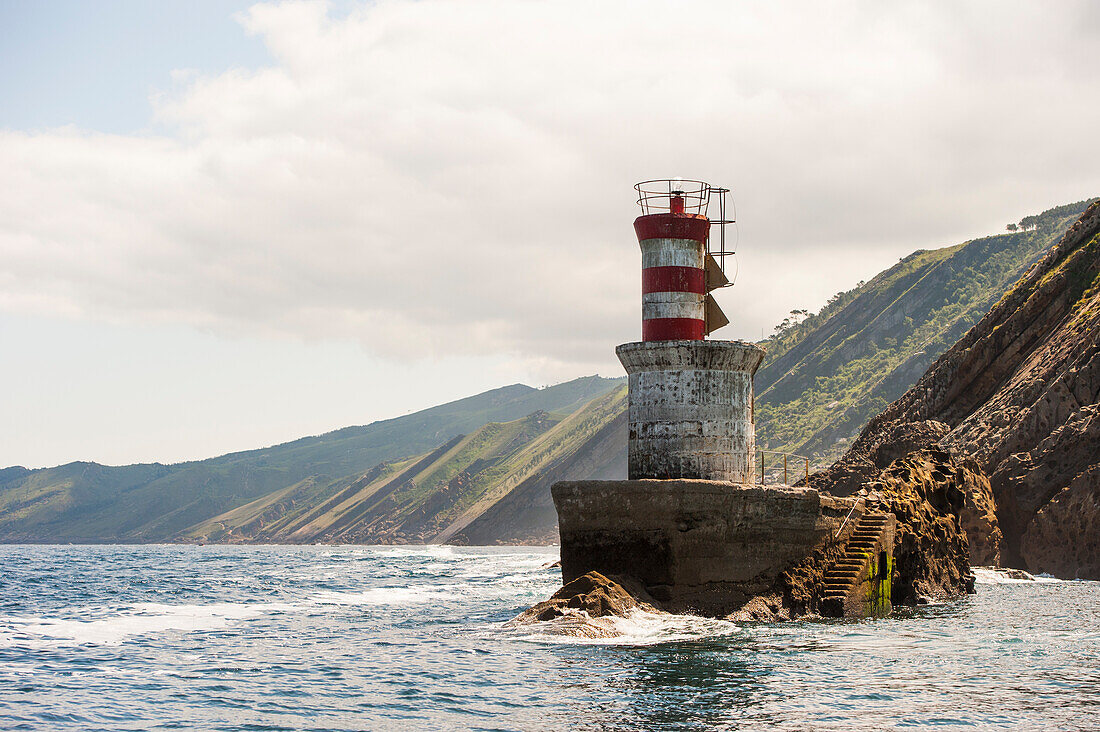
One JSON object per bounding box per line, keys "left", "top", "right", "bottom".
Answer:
{"left": 550, "top": 178, "right": 894, "bottom": 618}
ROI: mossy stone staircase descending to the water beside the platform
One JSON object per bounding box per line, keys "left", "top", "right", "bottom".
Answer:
{"left": 820, "top": 512, "right": 894, "bottom": 618}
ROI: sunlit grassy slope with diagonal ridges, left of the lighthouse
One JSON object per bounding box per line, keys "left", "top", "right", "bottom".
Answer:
{"left": 179, "top": 386, "right": 626, "bottom": 543}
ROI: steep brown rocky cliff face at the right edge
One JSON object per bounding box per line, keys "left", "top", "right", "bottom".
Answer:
{"left": 811, "top": 203, "right": 1100, "bottom": 579}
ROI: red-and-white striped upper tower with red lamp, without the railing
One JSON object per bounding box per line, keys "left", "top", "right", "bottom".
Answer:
{"left": 634, "top": 190, "right": 711, "bottom": 341}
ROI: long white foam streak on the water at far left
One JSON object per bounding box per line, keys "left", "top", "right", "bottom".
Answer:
{"left": 0, "top": 602, "right": 282, "bottom": 646}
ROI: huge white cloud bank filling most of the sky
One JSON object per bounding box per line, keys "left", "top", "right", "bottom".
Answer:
{"left": 0, "top": 0, "right": 1100, "bottom": 379}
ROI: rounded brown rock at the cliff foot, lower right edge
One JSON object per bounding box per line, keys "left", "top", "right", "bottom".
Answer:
{"left": 1020, "top": 466, "right": 1100, "bottom": 580}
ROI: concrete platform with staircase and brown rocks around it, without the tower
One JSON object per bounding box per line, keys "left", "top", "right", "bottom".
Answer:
{"left": 521, "top": 442, "right": 996, "bottom": 621}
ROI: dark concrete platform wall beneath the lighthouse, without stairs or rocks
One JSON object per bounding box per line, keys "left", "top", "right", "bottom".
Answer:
{"left": 551, "top": 480, "right": 854, "bottom": 616}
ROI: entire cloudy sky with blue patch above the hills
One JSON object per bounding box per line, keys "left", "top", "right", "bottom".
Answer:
{"left": 0, "top": 0, "right": 1100, "bottom": 467}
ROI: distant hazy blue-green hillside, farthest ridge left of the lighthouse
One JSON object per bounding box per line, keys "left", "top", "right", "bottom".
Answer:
{"left": 0, "top": 376, "right": 623, "bottom": 542}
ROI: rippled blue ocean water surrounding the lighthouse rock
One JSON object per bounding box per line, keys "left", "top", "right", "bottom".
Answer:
{"left": 0, "top": 545, "right": 1100, "bottom": 730}
